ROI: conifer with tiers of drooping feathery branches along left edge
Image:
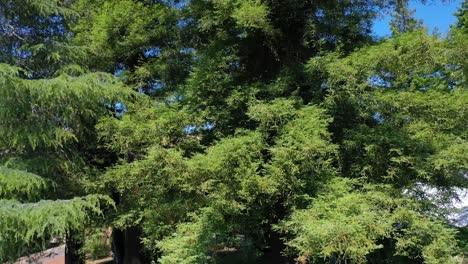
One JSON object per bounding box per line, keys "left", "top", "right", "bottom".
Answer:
{"left": 0, "top": 64, "right": 129, "bottom": 263}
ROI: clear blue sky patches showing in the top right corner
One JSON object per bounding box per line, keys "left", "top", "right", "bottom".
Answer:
{"left": 373, "top": 0, "right": 463, "bottom": 37}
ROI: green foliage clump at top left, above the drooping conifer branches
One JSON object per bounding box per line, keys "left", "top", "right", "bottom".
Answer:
{"left": 73, "top": 0, "right": 176, "bottom": 69}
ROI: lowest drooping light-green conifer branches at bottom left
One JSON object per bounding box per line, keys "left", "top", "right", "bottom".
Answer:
{"left": 0, "top": 167, "right": 111, "bottom": 263}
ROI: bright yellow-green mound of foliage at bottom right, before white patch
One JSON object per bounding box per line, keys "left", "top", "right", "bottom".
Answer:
{"left": 277, "top": 178, "right": 458, "bottom": 263}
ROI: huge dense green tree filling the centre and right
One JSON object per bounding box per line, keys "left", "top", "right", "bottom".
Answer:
{"left": 87, "top": 1, "right": 466, "bottom": 263}
